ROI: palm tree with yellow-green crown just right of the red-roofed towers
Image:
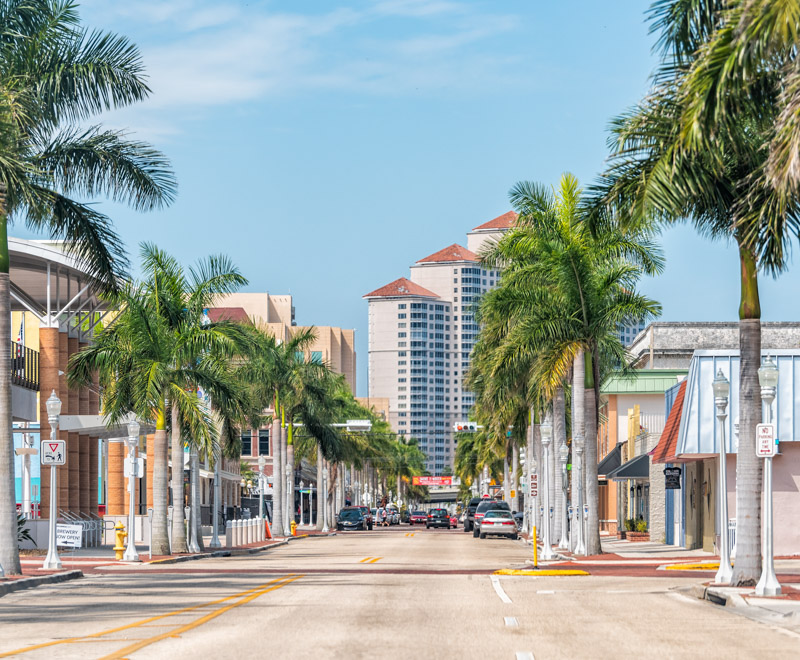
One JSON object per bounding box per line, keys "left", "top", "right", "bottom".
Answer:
{"left": 482, "top": 174, "right": 663, "bottom": 554}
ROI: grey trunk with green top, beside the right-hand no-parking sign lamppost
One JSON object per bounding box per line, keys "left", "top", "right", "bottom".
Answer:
{"left": 732, "top": 248, "right": 763, "bottom": 587}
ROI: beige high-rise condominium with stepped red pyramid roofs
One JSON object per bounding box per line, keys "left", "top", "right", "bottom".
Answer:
{"left": 364, "top": 211, "right": 517, "bottom": 474}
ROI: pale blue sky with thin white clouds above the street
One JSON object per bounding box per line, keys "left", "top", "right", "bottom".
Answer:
{"left": 16, "top": 0, "right": 800, "bottom": 394}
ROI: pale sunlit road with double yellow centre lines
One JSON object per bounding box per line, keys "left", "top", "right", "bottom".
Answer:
{"left": 0, "top": 525, "right": 800, "bottom": 660}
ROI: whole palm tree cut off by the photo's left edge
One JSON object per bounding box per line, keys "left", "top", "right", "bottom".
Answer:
{"left": 0, "top": 0, "right": 176, "bottom": 574}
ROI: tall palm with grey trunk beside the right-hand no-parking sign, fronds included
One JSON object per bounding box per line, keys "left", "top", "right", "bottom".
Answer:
{"left": 593, "top": 0, "right": 800, "bottom": 586}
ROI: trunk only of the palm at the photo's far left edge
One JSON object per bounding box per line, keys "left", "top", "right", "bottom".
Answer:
{"left": 0, "top": 211, "right": 19, "bottom": 575}
